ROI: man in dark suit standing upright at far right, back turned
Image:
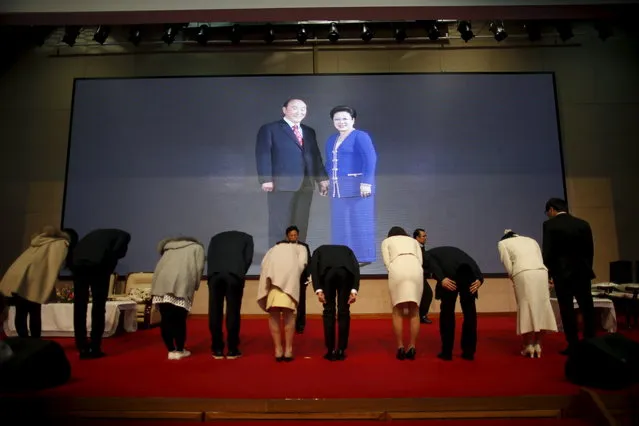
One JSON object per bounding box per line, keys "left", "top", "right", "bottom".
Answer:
{"left": 542, "top": 198, "right": 596, "bottom": 355}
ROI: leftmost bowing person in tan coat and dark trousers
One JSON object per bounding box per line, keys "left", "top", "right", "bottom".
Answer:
{"left": 0, "top": 226, "right": 78, "bottom": 337}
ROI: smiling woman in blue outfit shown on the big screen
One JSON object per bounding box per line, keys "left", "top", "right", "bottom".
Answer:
{"left": 324, "top": 105, "right": 377, "bottom": 265}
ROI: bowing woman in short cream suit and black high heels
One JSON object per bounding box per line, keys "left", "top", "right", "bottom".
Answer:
{"left": 382, "top": 226, "right": 424, "bottom": 360}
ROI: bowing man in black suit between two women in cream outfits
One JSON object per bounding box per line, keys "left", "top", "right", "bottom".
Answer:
{"left": 424, "top": 247, "right": 484, "bottom": 361}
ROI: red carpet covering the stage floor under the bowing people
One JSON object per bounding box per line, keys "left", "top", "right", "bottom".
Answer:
{"left": 22, "top": 316, "right": 632, "bottom": 398}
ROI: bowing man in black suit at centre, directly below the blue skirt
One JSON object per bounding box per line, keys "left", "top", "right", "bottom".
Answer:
{"left": 311, "top": 245, "right": 359, "bottom": 361}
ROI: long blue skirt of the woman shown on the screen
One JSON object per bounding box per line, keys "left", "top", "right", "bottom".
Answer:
{"left": 331, "top": 195, "right": 377, "bottom": 263}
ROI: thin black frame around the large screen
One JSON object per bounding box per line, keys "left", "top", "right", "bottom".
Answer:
{"left": 60, "top": 71, "right": 570, "bottom": 280}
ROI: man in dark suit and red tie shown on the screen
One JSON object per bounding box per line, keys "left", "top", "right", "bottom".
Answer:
{"left": 255, "top": 99, "right": 328, "bottom": 247}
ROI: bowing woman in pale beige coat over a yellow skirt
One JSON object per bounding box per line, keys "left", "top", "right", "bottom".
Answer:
{"left": 257, "top": 244, "right": 309, "bottom": 362}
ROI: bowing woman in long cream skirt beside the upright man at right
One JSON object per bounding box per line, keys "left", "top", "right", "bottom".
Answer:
{"left": 497, "top": 229, "right": 557, "bottom": 358}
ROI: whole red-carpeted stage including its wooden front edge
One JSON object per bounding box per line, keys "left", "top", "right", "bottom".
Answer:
{"left": 5, "top": 315, "right": 637, "bottom": 421}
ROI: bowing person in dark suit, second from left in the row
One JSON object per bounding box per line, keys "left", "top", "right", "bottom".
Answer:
{"left": 69, "top": 229, "right": 131, "bottom": 359}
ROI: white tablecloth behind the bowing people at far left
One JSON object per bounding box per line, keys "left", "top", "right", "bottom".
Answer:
{"left": 4, "top": 301, "right": 138, "bottom": 337}
